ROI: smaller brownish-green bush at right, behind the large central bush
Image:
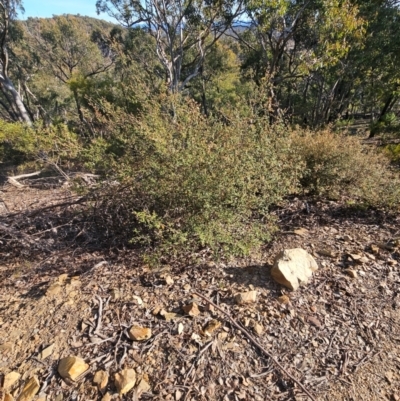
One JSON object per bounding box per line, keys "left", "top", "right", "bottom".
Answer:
{"left": 292, "top": 130, "right": 400, "bottom": 207}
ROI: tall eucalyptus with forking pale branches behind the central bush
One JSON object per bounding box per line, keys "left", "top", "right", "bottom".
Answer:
{"left": 97, "top": 0, "right": 244, "bottom": 93}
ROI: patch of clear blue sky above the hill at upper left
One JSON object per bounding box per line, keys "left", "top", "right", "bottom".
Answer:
{"left": 19, "top": 0, "right": 115, "bottom": 21}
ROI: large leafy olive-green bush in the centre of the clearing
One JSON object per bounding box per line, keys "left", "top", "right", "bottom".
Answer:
{"left": 92, "top": 98, "right": 300, "bottom": 255}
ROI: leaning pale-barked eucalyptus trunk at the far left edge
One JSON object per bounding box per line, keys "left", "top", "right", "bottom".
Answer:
{"left": 0, "top": 0, "right": 32, "bottom": 125}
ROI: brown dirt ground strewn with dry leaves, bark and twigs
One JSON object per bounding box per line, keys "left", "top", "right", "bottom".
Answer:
{"left": 0, "top": 185, "right": 400, "bottom": 401}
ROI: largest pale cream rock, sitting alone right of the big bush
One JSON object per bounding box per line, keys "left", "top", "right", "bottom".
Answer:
{"left": 271, "top": 248, "right": 318, "bottom": 291}
